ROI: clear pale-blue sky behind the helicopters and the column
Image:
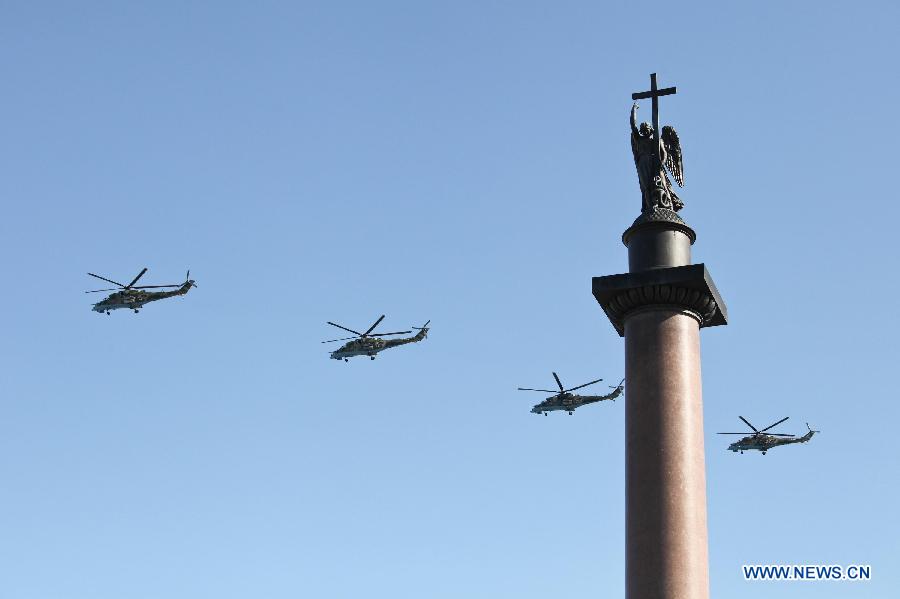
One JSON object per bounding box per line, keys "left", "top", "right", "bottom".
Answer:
{"left": 0, "top": 1, "right": 900, "bottom": 599}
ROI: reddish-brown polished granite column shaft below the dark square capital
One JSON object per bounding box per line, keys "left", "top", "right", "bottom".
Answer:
{"left": 625, "top": 308, "right": 709, "bottom": 599}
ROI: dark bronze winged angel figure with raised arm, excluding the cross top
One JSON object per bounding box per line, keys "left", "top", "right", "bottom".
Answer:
{"left": 631, "top": 102, "right": 684, "bottom": 212}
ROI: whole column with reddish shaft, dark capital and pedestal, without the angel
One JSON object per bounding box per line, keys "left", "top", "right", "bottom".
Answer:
{"left": 593, "top": 209, "right": 726, "bottom": 599}
